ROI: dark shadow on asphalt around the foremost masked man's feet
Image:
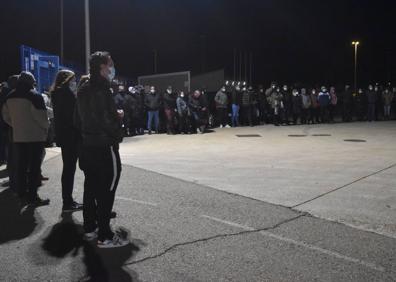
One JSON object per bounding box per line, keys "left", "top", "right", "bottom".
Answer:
{"left": 41, "top": 213, "right": 140, "bottom": 282}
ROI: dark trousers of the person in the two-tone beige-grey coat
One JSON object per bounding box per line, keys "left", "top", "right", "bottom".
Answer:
{"left": 13, "top": 142, "right": 44, "bottom": 200}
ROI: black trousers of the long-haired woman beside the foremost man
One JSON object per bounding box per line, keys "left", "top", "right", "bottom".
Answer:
{"left": 61, "top": 143, "right": 78, "bottom": 205}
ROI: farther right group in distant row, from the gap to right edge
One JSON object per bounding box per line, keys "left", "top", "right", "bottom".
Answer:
{"left": 214, "top": 83, "right": 396, "bottom": 127}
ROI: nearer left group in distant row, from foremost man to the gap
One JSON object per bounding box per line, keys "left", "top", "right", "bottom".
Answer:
{"left": 114, "top": 85, "right": 209, "bottom": 136}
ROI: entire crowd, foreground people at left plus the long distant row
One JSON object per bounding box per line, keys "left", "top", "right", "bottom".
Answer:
{"left": 0, "top": 52, "right": 396, "bottom": 248}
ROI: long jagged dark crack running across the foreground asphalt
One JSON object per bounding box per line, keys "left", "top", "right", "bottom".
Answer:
{"left": 124, "top": 213, "right": 307, "bottom": 266}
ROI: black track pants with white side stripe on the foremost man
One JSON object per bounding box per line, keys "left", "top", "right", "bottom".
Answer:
{"left": 80, "top": 145, "right": 121, "bottom": 241}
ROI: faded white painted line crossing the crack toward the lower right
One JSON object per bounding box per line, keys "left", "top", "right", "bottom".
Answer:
{"left": 201, "top": 215, "right": 385, "bottom": 272}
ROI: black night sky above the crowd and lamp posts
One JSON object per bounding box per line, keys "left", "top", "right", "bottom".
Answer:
{"left": 0, "top": 0, "right": 396, "bottom": 86}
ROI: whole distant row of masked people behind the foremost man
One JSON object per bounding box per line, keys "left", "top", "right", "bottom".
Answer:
{"left": 109, "top": 82, "right": 396, "bottom": 136}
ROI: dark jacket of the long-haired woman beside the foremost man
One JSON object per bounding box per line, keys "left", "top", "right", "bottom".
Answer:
{"left": 51, "top": 87, "right": 81, "bottom": 147}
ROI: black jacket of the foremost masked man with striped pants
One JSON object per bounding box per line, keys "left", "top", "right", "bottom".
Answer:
{"left": 74, "top": 77, "right": 123, "bottom": 147}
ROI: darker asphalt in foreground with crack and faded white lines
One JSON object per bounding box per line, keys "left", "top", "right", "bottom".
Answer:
{"left": 0, "top": 122, "right": 396, "bottom": 282}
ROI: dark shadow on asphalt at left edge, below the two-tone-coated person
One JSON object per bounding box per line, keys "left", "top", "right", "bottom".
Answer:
{"left": 0, "top": 189, "right": 41, "bottom": 244}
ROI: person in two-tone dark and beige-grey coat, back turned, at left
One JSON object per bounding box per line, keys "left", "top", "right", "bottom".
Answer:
{"left": 2, "top": 72, "right": 49, "bottom": 206}
